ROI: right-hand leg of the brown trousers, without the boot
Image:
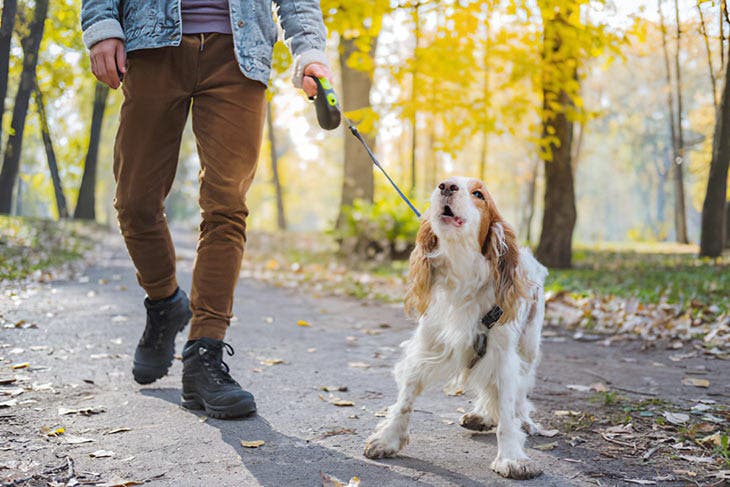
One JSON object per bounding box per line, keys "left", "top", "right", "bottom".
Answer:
{"left": 189, "top": 34, "right": 266, "bottom": 340}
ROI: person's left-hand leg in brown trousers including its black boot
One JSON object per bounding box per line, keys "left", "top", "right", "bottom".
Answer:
{"left": 114, "top": 39, "right": 195, "bottom": 384}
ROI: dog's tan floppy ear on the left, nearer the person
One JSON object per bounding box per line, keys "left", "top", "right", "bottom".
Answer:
{"left": 404, "top": 215, "right": 438, "bottom": 318}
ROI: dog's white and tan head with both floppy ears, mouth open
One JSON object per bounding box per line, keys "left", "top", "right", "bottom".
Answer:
{"left": 405, "top": 177, "right": 525, "bottom": 322}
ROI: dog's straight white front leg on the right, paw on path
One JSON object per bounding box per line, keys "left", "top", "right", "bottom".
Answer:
{"left": 492, "top": 351, "right": 542, "bottom": 479}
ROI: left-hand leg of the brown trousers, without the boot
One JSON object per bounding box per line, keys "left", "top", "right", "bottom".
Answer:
{"left": 114, "top": 44, "right": 195, "bottom": 300}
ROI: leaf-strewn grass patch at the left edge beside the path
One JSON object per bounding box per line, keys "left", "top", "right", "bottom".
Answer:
{"left": 0, "top": 216, "right": 94, "bottom": 281}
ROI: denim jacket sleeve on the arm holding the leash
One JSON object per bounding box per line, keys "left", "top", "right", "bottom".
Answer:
{"left": 274, "top": 0, "right": 328, "bottom": 88}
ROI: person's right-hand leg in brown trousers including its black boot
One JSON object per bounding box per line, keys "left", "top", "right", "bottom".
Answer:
{"left": 182, "top": 34, "right": 266, "bottom": 418}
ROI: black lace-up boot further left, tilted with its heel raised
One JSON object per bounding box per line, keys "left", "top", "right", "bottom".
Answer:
{"left": 132, "top": 288, "right": 193, "bottom": 384}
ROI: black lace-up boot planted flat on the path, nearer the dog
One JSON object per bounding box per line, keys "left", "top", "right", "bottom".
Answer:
{"left": 182, "top": 338, "right": 256, "bottom": 419}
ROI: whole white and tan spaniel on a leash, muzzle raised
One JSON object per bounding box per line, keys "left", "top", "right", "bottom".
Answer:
{"left": 364, "top": 177, "right": 547, "bottom": 479}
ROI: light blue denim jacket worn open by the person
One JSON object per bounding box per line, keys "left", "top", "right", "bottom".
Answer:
{"left": 81, "top": 0, "right": 327, "bottom": 86}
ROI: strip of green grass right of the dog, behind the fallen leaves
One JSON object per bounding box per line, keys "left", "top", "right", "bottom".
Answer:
{"left": 546, "top": 244, "right": 730, "bottom": 311}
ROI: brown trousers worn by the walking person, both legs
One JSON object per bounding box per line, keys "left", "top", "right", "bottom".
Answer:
{"left": 114, "top": 34, "right": 266, "bottom": 340}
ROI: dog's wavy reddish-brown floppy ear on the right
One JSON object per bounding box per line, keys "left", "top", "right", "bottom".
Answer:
{"left": 482, "top": 213, "right": 527, "bottom": 323}
